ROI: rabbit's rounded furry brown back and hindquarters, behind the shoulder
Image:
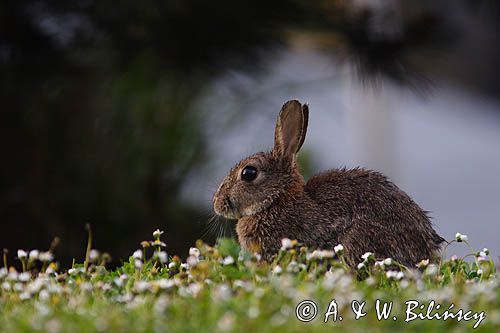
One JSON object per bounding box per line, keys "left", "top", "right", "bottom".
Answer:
{"left": 304, "top": 168, "right": 443, "bottom": 265}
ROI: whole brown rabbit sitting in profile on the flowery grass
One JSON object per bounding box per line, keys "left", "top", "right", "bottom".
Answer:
{"left": 213, "top": 100, "right": 444, "bottom": 266}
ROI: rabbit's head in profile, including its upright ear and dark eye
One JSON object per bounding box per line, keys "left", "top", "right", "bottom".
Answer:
{"left": 213, "top": 100, "right": 309, "bottom": 219}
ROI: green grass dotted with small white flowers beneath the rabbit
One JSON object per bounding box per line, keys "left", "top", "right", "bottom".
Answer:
{"left": 0, "top": 233, "right": 500, "bottom": 333}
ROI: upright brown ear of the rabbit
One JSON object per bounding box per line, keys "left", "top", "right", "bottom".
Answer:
{"left": 273, "top": 100, "right": 309, "bottom": 158}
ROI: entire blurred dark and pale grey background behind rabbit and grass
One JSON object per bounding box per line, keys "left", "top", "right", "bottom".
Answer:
{"left": 0, "top": 0, "right": 500, "bottom": 264}
